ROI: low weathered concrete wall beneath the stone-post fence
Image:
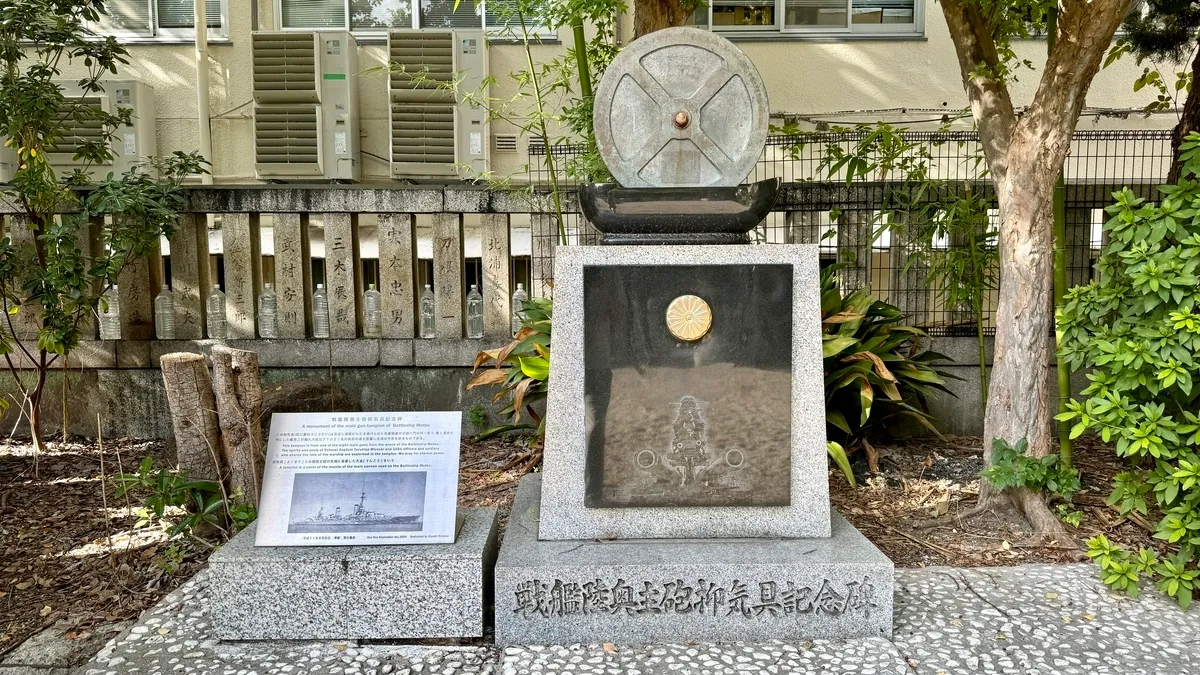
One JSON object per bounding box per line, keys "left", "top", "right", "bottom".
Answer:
{"left": 0, "top": 338, "right": 1086, "bottom": 438}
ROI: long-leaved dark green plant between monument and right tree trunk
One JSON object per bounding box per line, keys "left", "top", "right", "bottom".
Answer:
{"left": 821, "top": 265, "right": 954, "bottom": 448}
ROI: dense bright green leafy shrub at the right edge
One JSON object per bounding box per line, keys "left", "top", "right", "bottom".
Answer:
{"left": 1057, "top": 133, "right": 1200, "bottom": 605}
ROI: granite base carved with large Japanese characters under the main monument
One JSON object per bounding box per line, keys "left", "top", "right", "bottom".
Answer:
{"left": 496, "top": 474, "right": 894, "bottom": 645}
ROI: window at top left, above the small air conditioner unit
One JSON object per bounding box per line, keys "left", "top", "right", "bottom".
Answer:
{"left": 94, "top": 0, "right": 229, "bottom": 40}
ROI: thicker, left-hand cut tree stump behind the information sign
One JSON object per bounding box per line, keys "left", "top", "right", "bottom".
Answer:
{"left": 161, "top": 353, "right": 222, "bottom": 482}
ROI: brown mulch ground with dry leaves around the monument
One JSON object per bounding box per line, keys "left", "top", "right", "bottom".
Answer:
{"left": 0, "top": 437, "right": 1159, "bottom": 658}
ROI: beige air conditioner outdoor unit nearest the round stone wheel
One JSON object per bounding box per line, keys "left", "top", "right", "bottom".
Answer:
{"left": 388, "top": 30, "right": 491, "bottom": 177}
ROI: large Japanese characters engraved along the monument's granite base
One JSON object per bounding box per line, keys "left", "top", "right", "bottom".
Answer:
{"left": 512, "top": 577, "right": 878, "bottom": 620}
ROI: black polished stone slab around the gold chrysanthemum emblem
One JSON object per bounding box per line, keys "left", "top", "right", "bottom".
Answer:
{"left": 583, "top": 264, "right": 792, "bottom": 508}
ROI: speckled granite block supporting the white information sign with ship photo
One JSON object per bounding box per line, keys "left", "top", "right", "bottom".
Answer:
{"left": 209, "top": 508, "right": 497, "bottom": 640}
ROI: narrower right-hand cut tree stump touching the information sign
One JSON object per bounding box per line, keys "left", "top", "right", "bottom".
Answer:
{"left": 212, "top": 346, "right": 265, "bottom": 507}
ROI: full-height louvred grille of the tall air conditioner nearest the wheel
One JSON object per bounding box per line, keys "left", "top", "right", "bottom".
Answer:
{"left": 388, "top": 31, "right": 456, "bottom": 165}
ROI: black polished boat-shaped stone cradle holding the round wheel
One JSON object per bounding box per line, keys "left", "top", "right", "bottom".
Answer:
{"left": 578, "top": 178, "right": 780, "bottom": 245}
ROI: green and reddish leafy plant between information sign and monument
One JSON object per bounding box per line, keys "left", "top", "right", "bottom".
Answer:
{"left": 467, "top": 298, "right": 553, "bottom": 440}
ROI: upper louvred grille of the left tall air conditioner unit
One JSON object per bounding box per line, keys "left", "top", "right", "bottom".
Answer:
{"left": 252, "top": 32, "right": 318, "bottom": 103}
